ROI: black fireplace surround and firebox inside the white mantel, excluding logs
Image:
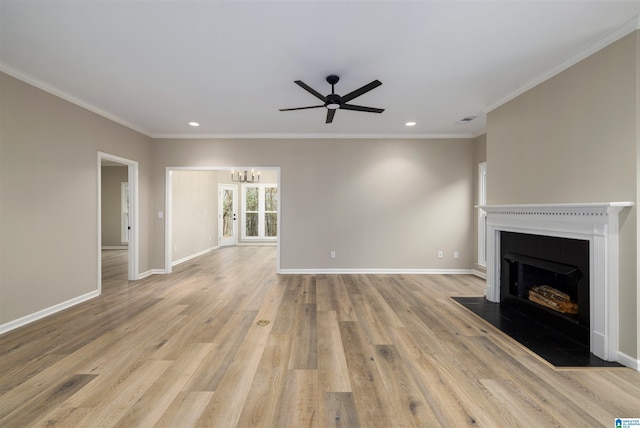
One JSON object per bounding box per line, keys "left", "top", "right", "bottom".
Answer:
{"left": 500, "top": 231, "right": 590, "bottom": 347}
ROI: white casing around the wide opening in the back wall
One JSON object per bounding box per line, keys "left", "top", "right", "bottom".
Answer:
{"left": 165, "top": 165, "right": 284, "bottom": 274}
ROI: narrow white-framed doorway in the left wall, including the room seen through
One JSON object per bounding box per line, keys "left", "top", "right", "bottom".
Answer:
{"left": 97, "top": 152, "right": 138, "bottom": 292}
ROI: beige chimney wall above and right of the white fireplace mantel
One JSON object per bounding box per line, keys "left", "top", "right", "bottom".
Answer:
{"left": 487, "top": 32, "right": 640, "bottom": 357}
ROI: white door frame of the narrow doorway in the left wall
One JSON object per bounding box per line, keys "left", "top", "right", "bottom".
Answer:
{"left": 97, "top": 152, "right": 139, "bottom": 293}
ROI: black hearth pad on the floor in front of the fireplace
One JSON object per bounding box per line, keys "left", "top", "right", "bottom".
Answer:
{"left": 452, "top": 296, "right": 623, "bottom": 367}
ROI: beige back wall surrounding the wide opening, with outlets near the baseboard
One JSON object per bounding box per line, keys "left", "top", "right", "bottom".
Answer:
{"left": 153, "top": 139, "right": 475, "bottom": 269}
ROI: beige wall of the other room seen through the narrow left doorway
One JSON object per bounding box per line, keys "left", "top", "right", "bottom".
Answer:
{"left": 100, "top": 166, "right": 129, "bottom": 247}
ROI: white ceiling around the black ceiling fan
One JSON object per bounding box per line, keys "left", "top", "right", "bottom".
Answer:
{"left": 0, "top": 0, "right": 640, "bottom": 137}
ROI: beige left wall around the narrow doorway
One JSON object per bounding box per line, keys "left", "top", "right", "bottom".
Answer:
{"left": 0, "top": 73, "right": 151, "bottom": 325}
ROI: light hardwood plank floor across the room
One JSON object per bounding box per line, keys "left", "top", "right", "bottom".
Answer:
{"left": 0, "top": 247, "right": 640, "bottom": 428}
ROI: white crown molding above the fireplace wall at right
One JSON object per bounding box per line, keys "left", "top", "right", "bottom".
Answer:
{"left": 482, "top": 15, "right": 640, "bottom": 113}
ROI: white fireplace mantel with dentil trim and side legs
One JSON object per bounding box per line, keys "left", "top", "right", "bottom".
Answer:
{"left": 479, "top": 202, "right": 633, "bottom": 361}
